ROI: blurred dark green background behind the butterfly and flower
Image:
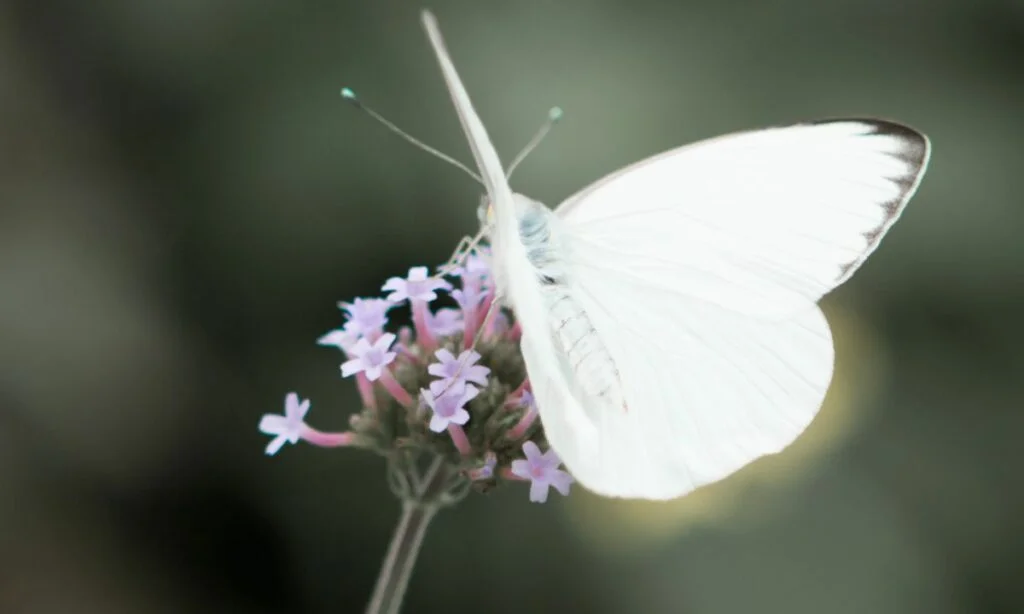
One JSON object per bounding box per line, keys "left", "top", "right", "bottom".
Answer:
{"left": 0, "top": 0, "right": 1024, "bottom": 614}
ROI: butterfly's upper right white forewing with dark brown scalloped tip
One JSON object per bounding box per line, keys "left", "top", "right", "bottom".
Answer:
{"left": 557, "top": 120, "right": 930, "bottom": 316}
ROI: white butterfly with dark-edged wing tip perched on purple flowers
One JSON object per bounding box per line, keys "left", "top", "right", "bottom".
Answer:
{"left": 423, "top": 11, "right": 930, "bottom": 499}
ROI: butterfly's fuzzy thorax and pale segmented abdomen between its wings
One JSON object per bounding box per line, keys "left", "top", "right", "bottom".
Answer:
{"left": 516, "top": 194, "right": 625, "bottom": 409}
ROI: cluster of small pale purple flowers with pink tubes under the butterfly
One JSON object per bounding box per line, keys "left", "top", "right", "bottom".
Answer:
{"left": 259, "top": 250, "right": 572, "bottom": 502}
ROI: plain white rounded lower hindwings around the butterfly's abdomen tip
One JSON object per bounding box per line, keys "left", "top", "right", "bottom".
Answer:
{"left": 522, "top": 278, "right": 833, "bottom": 499}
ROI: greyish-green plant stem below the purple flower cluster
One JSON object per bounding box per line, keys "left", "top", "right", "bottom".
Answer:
{"left": 367, "top": 457, "right": 450, "bottom": 614}
